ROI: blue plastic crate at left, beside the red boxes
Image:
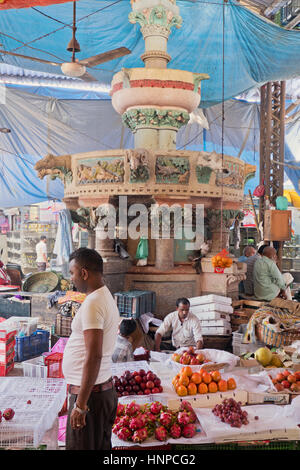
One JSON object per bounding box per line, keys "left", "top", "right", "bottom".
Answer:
{"left": 15, "top": 330, "right": 49, "bottom": 362}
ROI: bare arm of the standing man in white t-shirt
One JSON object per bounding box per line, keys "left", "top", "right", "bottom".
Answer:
{"left": 71, "top": 329, "right": 103, "bottom": 429}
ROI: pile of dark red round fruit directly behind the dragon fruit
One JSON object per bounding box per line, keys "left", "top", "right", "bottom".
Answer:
{"left": 113, "top": 369, "right": 163, "bottom": 397}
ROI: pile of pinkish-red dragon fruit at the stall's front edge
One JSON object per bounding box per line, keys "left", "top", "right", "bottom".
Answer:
{"left": 112, "top": 401, "right": 197, "bottom": 444}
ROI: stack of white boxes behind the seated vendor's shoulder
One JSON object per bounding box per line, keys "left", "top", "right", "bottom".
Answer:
{"left": 189, "top": 294, "right": 233, "bottom": 336}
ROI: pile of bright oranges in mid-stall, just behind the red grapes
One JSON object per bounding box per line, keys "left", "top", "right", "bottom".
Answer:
{"left": 172, "top": 366, "right": 236, "bottom": 397}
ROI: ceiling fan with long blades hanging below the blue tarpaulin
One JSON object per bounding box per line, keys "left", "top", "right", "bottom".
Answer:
{"left": 0, "top": 1, "right": 131, "bottom": 82}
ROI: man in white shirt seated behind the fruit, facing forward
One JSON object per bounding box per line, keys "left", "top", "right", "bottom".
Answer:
{"left": 155, "top": 297, "right": 203, "bottom": 351}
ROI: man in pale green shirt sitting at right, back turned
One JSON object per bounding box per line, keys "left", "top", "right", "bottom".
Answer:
{"left": 253, "top": 246, "right": 294, "bottom": 302}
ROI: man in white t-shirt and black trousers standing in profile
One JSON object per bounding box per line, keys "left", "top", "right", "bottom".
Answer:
{"left": 62, "top": 248, "right": 120, "bottom": 450}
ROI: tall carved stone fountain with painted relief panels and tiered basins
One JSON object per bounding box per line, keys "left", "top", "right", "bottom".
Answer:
{"left": 36, "top": 0, "right": 255, "bottom": 316}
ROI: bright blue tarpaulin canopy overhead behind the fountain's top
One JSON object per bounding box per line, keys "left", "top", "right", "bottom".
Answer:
{"left": 0, "top": 0, "right": 300, "bottom": 107}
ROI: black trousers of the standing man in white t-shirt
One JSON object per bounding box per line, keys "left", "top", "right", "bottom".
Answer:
{"left": 66, "top": 388, "right": 118, "bottom": 450}
